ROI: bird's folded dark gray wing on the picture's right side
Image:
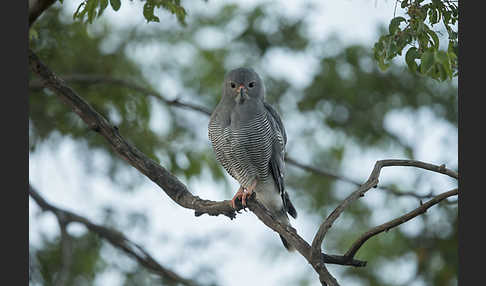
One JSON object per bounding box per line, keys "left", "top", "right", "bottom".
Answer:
{"left": 263, "top": 102, "right": 297, "bottom": 218}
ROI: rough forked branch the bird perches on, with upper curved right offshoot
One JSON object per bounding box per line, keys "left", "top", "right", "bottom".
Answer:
{"left": 29, "top": 49, "right": 458, "bottom": 286}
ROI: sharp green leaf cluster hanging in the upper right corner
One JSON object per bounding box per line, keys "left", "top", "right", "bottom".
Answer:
{"left": 374, "top": 0, "right": 459, "bottom": 81}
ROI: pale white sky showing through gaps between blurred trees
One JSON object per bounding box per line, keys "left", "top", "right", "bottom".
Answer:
{"left": 29, "top": 0, "right": 457, "bottom": 286}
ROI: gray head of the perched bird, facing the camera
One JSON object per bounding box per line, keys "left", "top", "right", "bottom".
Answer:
{"left": 223, "top": 68, "right": 265, "bottom": 103}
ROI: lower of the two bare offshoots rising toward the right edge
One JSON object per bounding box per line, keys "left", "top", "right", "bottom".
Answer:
{"left": 344, "top": 189, "right": 458, "bottom": 258}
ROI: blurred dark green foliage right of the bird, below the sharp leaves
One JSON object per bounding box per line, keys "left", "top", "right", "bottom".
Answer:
{"left": 298, "top": 43, "right": 457, "bottom": 151}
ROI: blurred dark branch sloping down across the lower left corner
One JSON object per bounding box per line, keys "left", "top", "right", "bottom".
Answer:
{"left": 29, "top": 184, "right": 196, "bottom": 286}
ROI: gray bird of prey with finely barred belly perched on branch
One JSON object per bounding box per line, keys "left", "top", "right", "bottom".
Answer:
{"left": 208, "top": 68, "right": 297, "bottom": 251}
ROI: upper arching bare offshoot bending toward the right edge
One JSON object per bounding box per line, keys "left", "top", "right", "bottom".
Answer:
{"left": 311, "top": 159, "right": 459, "bottom": 259}
